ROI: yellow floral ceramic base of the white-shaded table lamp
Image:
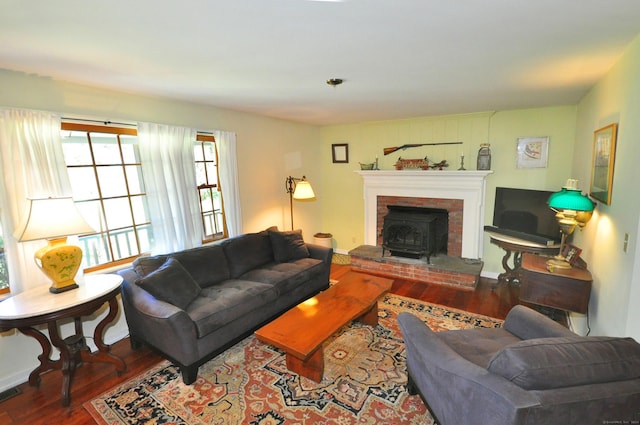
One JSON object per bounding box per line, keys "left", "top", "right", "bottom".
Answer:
{"left": 34, "top": 237, "right": 82, "bottom": 294}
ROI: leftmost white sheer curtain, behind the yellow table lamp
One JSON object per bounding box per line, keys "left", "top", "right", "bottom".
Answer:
{"left": 0, "top": 109, "right": 71, "bottom": 294}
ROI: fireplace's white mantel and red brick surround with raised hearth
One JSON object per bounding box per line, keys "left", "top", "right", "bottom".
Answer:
{"left": 349, "top": 170, "right": 491, "bottom": 289}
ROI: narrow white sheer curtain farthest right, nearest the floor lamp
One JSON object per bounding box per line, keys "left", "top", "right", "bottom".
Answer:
{"left": 213, "top": 130, "right": 242, "bottom": 237}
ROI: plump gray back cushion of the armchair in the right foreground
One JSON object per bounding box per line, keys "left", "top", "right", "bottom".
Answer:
{"left": 487, "top": 336, "right": 640, "bottom": 390}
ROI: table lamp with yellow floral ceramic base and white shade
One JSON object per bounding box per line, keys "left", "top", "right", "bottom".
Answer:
{"left": 14, "top": 197, "right": 95, "bottom": 294}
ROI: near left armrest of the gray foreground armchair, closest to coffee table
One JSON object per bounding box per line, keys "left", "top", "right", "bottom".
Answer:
{"left": 398, "top": 313, "right": 540, "bottom": 424}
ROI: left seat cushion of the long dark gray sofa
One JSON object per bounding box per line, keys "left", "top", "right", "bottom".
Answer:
{"left": 187, "top": 279, "right": 278, "bottom": 338}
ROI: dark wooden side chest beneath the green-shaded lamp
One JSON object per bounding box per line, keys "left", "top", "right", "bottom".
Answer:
{"left": 520, "top": 254, "right": 593, "bottom": 314}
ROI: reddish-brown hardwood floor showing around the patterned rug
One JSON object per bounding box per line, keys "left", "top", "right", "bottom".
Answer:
{"left": 0, "top": 264, "right": 519, "bottom": 425}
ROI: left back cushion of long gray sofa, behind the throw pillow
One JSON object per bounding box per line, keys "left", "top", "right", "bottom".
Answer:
{"left": 133, "top": 245, "right": 231, "bottom": 288}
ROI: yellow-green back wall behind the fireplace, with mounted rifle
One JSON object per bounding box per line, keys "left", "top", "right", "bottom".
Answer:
{"left": 321, "top": 106, "right": 576, "bottom": 276}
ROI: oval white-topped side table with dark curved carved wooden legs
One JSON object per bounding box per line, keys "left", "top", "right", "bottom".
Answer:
{"left": 0, "top": 274, "right": 126, "bottom": 406}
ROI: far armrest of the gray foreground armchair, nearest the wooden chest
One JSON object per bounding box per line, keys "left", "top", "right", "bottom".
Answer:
{"left": 504, "top": 305, "right": 576, "bottom": 339}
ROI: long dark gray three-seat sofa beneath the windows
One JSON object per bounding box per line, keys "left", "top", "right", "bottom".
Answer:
{"left": 119, "top": 228, "right": 333, "bottom": 384}
